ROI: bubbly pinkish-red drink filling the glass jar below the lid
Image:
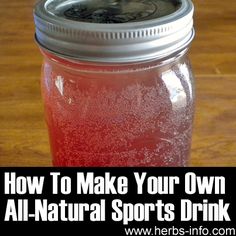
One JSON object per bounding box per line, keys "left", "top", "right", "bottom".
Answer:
{"left": 42, "top": 53, "right": 193, "bottom": 166}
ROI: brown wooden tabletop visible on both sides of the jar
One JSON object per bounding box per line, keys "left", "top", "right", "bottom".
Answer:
{"left": 0, "top": 0, "right": 236, "bottom": 166}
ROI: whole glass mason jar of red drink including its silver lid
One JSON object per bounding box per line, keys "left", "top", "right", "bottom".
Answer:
{"left": 34, "top": 0, "right": 194, "bottom": 166}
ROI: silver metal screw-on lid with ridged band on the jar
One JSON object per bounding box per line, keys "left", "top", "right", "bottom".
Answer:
{"left": 34, "top": 0, "right": 194, "bottom": 63}
